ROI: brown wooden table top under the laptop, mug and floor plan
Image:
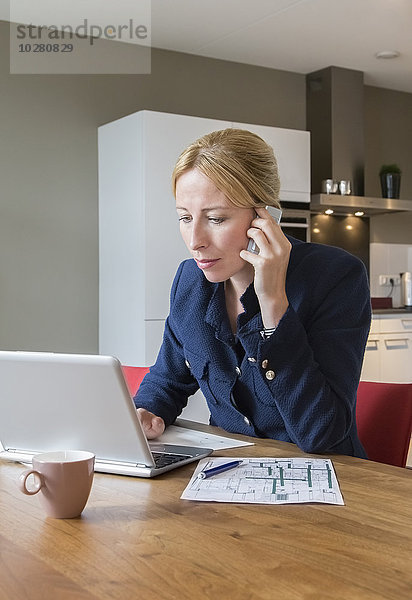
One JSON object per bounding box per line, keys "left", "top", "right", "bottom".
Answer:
{"left": 0, "top": 424, "right": 412, "bottom": 600}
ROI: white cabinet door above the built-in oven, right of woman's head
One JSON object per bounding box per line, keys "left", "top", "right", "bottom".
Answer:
{"left": 233, "top": 123, "right": 310, "bottom": 208}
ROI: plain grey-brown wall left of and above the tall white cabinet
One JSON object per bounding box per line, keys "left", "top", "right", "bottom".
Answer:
{"left": 0, "top": 22, "right": 305, "bottom": 353}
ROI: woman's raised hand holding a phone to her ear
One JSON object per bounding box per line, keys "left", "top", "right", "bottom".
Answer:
{"left": 240, "top": 208, "right": 292, "bottom": 328}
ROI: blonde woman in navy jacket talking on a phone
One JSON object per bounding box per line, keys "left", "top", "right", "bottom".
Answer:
{"left": 135, "top": 129, "right": 371, "bottom": 457}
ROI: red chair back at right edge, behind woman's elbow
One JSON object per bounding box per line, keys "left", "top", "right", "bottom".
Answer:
{"left": 356, "top": 381, "right": 412, "bottom": 467}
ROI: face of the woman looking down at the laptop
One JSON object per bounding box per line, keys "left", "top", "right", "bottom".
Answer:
{"left": 176, "top": 169, "right": 255, "bottom": 283}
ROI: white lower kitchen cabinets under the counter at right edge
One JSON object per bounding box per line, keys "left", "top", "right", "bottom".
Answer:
{"left": 361, "top": 313, "right": 412, "bottom": 383}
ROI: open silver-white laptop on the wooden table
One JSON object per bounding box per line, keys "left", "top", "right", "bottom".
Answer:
{"left": 0, "top": 351, "right": 213, "bottom": 477}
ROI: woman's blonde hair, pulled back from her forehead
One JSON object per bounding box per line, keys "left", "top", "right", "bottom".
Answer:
{"left": 172, "top": 129, "right": 280, "bottom": 208}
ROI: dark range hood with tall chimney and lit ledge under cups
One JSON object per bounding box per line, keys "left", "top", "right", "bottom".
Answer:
{"left": 306, "top": 67, "right": 412, "bottom": 216}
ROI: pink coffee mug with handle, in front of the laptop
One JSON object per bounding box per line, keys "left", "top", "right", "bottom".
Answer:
{"left": 19, "top": 450, "right": 95, "bottom": 519}
